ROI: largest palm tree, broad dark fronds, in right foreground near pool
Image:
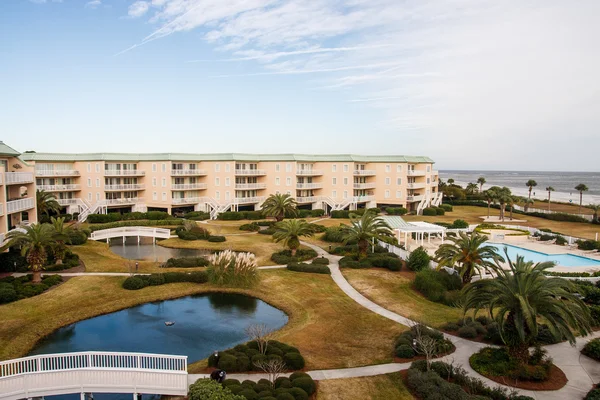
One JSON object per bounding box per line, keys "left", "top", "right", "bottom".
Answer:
{"left": 462, "top": 253, "right": 591, "bottom": 363}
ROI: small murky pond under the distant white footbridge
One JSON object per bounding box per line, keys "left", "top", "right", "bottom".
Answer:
{"left": 110, "top": 237, "right": 203, "bottom": 262}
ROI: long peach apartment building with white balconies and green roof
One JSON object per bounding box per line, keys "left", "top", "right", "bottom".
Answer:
{"left": 1, "top": 149, "right": 441, "bottom": 225}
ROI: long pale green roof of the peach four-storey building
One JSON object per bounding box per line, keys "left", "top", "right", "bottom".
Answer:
{"left": 22, "top": 152, "right": 434, "bottom": 163}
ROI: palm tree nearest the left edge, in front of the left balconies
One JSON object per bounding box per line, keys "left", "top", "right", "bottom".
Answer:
{"left": 4, "top": 223, "right": 55, "bottom": 283}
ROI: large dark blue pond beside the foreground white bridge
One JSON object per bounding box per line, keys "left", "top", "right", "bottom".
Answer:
{"left": 30, "top": 293, "right": 288, "bottom": 400}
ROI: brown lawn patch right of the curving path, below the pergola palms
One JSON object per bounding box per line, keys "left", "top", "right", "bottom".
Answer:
{"left": 342, "top": 268, "right": 462, "bottom": 327}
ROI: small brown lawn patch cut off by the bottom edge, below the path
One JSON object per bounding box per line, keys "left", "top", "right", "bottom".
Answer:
{"left": 317, "top": 372, "right": 414, "bottom": 400}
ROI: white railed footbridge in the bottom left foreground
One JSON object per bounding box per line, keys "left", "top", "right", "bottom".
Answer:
{"left": 0, "top": 351, "right": 188, "bottom": 400}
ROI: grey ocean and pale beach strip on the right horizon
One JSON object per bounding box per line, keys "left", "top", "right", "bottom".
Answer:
{"left": 440, "top": 170, "right": 600, "bottom": 204}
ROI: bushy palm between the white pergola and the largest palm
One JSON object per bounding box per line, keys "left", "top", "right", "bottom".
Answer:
{"left": 435, "top": 232, "right": 504, "bottom": 284}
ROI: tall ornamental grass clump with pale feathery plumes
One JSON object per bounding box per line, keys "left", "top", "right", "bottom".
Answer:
{"left": 207, "top": 250, "right": 258, "bottom": 287}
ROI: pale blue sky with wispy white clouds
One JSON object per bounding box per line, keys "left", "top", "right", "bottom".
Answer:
{"left": 0, "top": 0, "right": 600, "bottom": 171}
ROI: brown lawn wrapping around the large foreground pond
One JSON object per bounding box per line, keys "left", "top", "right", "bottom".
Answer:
{"left": 0, "top": 270, "right": 406, "bottom": 372}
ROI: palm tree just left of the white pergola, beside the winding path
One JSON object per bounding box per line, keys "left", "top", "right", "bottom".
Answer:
{"left": 342, "top": 212, "right": 394, "bottom": 259}
